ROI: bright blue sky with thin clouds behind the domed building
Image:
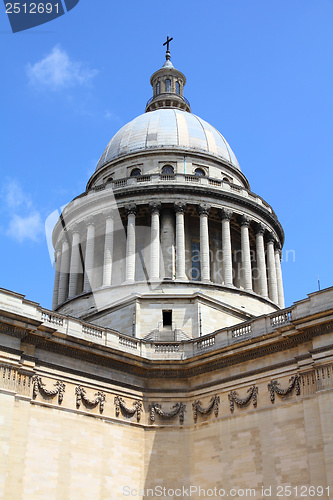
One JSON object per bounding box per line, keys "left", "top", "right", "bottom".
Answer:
{"left": 0, "top": 0, "right": 333, "bottom": 308}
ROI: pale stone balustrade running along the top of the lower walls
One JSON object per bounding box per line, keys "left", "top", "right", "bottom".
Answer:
{"left": 0, "top": 287, "right": 333, "bottom": 360}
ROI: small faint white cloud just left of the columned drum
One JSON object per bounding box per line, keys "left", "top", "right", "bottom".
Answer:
{"left": 7, "top": 212, "right": 43, "bottom": 243}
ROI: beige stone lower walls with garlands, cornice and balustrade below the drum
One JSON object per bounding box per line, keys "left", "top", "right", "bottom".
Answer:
{"left": 0, "top": 289, "right": 333, "bottom": 500}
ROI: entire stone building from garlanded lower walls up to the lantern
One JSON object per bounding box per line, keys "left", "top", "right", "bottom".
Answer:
{"left": 0, "top": 45, "right": 333, "bottom": 500}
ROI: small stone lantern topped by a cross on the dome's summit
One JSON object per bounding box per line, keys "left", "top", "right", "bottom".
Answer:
{"left": 146, "top": 37, "right": 191, "bottom": 113}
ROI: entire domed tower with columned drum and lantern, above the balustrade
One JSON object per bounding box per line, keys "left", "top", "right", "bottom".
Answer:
{"left": 53, "top": 45, "right": 284, "bottom": 340}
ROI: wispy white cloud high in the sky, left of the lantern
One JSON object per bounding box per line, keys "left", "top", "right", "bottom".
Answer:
{"left": 27, "top": 45, "right": 97, "bottom": 91}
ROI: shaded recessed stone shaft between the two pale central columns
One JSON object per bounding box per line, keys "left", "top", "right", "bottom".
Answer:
{"left": 161, "top": 208, "right": 175, "bottom": 279}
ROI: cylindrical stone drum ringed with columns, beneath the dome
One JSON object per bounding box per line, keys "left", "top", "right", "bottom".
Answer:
{"left": 54, "top": 186, "right": 282, "bottom": 337}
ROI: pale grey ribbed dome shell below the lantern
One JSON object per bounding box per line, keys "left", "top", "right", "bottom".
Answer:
{"left": 96, "top": 108, "right": 240, "bottom": 170}
